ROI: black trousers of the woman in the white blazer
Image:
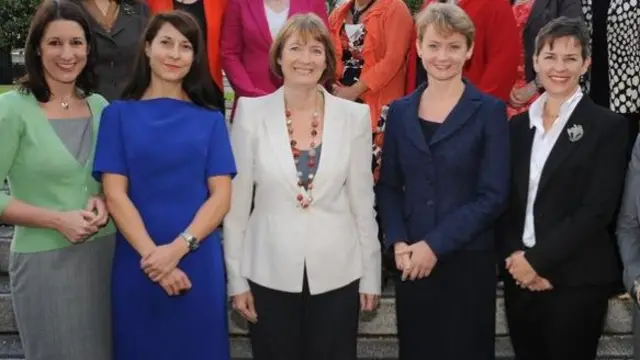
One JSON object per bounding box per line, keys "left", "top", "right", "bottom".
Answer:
{"left": 249, "top": 274, "right": 360, "bottom": 360}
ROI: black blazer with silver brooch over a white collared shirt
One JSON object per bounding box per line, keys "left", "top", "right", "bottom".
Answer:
{"left": 496, "top": 95, "right": 627, "bottom": 287}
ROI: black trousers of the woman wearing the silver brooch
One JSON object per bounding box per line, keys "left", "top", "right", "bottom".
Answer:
{"left": 505, "top": 280, "right": 612, "bottom": 360}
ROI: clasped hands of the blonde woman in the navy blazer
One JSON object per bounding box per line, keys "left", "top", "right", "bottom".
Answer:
{"left": 394, "top": 241, "right": 438, "bottom": 281}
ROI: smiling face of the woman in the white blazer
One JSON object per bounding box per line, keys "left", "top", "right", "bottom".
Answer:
{"left": 278, "top": 34, "right": 327, "bottom": 85}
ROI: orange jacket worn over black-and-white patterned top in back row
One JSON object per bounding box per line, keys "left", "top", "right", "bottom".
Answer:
{"left": 329, "top": 0, "right": 414, "bottom": 128}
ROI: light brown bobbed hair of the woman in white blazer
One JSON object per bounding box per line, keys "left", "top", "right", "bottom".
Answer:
{"left": 269, "top": 13, "right": 337, "bottom": 84}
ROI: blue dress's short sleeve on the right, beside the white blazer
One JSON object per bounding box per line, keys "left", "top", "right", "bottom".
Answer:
{"left": 207, "top": 112, "right": 237, "bottom": 178}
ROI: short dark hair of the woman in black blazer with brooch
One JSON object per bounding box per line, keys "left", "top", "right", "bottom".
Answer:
{"left": 534, "top": 16, "right": 591, "bottom": 60}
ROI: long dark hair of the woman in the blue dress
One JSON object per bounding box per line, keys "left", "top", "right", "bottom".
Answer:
{"left": 122, "top": 10, "right": 224, "bottom": 111}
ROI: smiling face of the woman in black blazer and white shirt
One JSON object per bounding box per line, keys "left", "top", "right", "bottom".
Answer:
{"left": 533, "top": 36, "right": 591, "bottom": 97}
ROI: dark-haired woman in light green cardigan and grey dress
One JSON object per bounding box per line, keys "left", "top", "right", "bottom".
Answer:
{"left": 0, "top": 0, "right": 114, "bottom": 360}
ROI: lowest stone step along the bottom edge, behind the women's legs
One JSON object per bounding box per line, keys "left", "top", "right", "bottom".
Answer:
{"left": 0, "top": 334, "right": 633, "bottom": 360}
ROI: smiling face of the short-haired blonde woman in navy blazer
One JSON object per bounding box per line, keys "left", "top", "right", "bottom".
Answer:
{"left": 416, "top": 25, "right": 473, "bottom": 81}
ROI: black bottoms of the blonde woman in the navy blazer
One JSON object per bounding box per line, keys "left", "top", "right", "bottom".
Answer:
{"left": 396, "top": 251, "right": 496, "bottom": 360}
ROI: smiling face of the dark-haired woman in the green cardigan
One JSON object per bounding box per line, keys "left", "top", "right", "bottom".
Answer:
{"left": 38, "top": 20, "right": 89, "bottom": 84}
